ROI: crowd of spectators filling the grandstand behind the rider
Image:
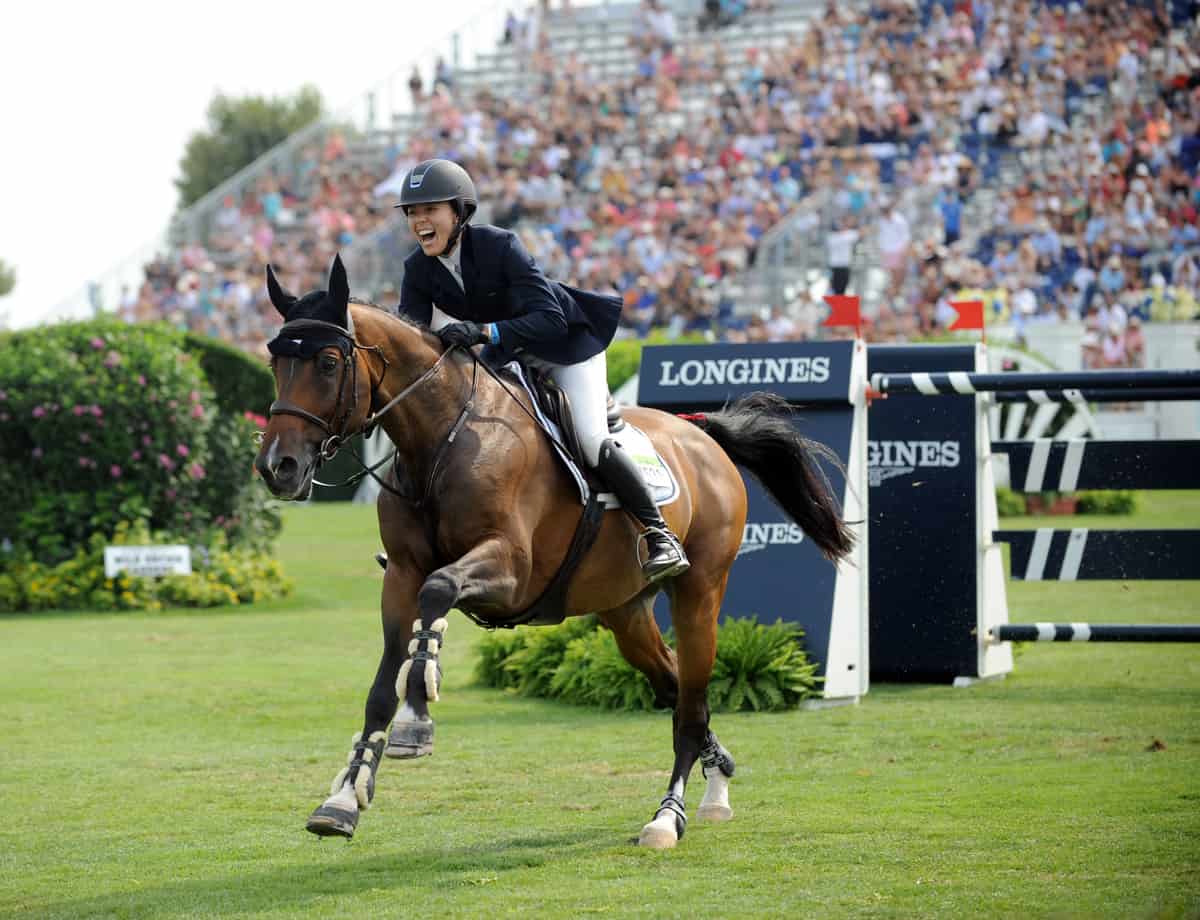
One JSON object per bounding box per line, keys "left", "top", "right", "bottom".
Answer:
{"left": 114, "top": 0, "right": 1200, "bottom": 366}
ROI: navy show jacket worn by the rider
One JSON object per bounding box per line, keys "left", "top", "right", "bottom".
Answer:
{"left": 400, "top": 224, "right": 620, "bottom": 365}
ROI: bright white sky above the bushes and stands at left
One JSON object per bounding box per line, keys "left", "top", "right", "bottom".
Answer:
{"left": 0, "top": 0, "right": 506, "bottom": 326}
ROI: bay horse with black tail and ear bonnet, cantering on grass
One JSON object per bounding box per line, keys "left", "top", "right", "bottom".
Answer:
{"left": 256, "top": 258, "right": 854, "bottom": 848}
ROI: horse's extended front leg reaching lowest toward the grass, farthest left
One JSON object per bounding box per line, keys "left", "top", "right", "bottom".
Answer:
{"left": 307, "top": 561, "right": 422, "bottom": 837}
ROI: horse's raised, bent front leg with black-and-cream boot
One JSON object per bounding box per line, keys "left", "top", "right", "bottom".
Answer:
{"left": 386, "top": 539, "right": 520, "bottom": 758}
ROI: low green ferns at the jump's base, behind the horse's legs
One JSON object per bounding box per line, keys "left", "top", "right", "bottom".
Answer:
{"left": 475, "top": 617, "right": 820, "bottom": 711}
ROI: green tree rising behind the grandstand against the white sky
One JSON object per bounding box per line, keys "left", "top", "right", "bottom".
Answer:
{"left": 175, "top": 85, "right": 324, "bottom": 208}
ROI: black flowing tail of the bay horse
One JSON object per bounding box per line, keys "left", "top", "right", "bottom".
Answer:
{"left": 683, "top": 392, "right": 854, "bottom": 563}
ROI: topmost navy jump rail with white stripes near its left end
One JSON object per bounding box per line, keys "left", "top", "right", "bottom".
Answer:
{"left": 871, "top": 369, "right": 1200, "bottom": 402}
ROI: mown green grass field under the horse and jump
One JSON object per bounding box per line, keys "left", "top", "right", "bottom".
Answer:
{"left": 0, "top": 493, "right": 1200, "bottom": 918}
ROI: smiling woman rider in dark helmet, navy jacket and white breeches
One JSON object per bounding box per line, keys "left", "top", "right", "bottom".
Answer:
{"left": 396, "top": 160, "right": 689, "bottom": 581}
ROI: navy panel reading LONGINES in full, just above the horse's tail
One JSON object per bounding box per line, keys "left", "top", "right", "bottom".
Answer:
{"left": 637, "top": 342, "right": 854, "bottom": 408}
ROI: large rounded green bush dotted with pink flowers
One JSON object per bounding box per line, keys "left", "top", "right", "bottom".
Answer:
{"left": 0, "top": 320, "right": 214, "bottom": 561}
